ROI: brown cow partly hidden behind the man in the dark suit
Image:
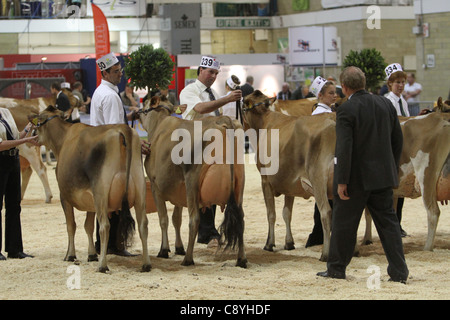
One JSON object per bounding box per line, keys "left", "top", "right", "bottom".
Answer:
{"left": 244, "top": 90, "right": 336, "bottom": 261}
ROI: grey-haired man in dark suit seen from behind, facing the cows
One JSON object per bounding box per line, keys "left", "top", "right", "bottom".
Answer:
{"left": 317, "top": 67, "right": 409, "bottom": 283}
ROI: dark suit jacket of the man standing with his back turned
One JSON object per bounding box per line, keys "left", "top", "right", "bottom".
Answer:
{"left": 334, "top": 90, "right": 403, "bottom": 191}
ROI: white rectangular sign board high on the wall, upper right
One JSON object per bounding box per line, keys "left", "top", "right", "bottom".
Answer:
{"left": 289, "top": 27, "right": 339, "bottom": 66}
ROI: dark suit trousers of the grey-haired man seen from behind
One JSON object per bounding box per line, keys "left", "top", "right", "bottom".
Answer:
{"left": 327, "top": 188, "right": 409, "bottom": 281}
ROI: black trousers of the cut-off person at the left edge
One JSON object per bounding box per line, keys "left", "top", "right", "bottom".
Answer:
{"left": 0, "top": 155, "right": 23, "bottom": 254}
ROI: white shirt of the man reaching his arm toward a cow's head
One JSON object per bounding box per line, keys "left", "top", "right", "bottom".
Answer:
{"left": 180, "top": 79, "right": 218, "bottom": 120}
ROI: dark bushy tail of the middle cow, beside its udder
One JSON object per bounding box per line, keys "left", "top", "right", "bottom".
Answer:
{"left": 219, "top": 164, "right": 244, "bottom": 250}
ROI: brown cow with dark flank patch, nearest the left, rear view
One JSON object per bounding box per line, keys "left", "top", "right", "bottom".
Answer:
{"left": 30, "top": 106, "right": 151, "bottom": 272}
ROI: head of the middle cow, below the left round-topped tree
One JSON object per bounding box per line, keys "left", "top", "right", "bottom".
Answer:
{"left": 138, "top": 96, "right": 174, "bottom": 141}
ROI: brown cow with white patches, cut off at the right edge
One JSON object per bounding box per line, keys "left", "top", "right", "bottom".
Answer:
{"left": 394, "top": 112, "right": 450, "bottom": 250}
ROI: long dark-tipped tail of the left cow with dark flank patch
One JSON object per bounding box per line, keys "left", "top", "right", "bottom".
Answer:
{"left": 118, "top": 132, "right": 135, "bottom": 249}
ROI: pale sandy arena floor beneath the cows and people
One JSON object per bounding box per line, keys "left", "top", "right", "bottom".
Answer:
{"left": 0, "top": 154, "right": 450, "bottom": 300}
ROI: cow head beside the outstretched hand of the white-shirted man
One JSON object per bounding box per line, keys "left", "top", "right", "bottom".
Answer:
{"left": 242, "top": 90, "right": 277, "bottom": 129}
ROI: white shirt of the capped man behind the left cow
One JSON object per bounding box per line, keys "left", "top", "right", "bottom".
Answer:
{"left": 91, "top": 79, "right": 125, "bottom": 126}
